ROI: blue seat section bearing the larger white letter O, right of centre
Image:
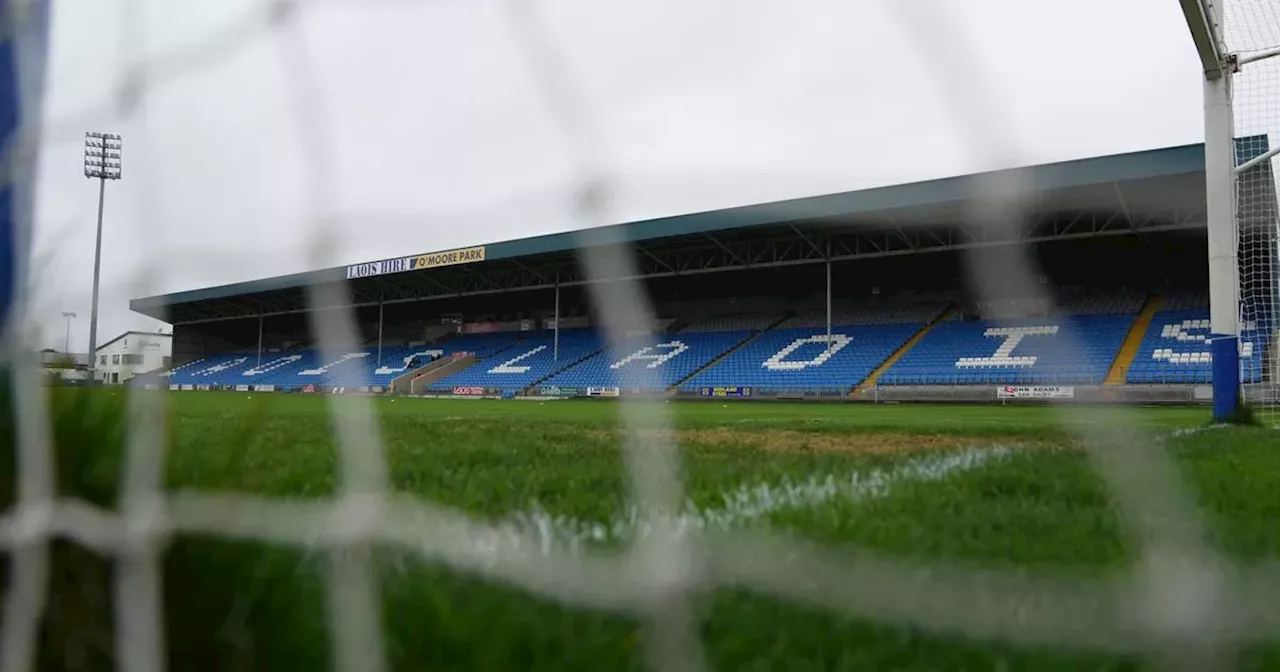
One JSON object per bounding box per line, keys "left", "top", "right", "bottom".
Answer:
{"left": 680, "top": 323, "right": 924, "bottom": 393}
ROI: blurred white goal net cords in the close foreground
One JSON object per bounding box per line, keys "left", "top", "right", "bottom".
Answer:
{"left": 0, "top": 0, "right": 1280, "bottom": 672}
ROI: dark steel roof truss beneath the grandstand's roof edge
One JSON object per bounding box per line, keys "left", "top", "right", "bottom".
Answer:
{"left": 161, "top": 210, "right": 1204, "bottom": 324}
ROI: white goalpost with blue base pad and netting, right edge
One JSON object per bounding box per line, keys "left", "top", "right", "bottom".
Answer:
{"left": 1180, "top": 0, "right": 1280, "bottom": 425}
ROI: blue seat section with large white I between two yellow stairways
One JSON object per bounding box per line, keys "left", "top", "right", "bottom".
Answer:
{"left": 878, "top": 315, "right": 1134, "bottom": 385}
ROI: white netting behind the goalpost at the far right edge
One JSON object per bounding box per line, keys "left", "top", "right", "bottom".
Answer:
{"left": 1222, "top": 0, "right": 1280, "bottom": 425}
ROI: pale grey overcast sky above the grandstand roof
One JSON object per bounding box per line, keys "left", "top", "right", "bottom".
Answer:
{"left": 27, "top": 0, "right": 1203, "bottom": 352}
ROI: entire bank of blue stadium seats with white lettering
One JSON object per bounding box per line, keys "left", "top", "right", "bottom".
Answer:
{"left": 169, "top": 296, "right": 1249, "bottom": 393}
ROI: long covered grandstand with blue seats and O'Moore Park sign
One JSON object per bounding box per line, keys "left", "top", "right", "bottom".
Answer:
{"left": 132, "top": 145, "right": 1276, "bottom": 403}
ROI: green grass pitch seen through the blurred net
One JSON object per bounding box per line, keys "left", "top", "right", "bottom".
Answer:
{"left": 0, "top": 390, "right": 1280, "bottom": 672}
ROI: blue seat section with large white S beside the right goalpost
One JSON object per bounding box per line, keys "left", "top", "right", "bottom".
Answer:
{"left": 1125, "top": 308, "right": 1268, "bottom": 384}
